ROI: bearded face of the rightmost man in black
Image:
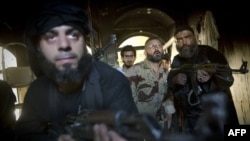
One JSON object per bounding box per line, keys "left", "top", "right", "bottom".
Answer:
{"left": 175, "top": 30, "right": 197, "bottom": 58}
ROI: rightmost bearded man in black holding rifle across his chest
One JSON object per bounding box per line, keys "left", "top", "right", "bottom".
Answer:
{"left": 168, "top": 26, "right": 239, "bottom": 134}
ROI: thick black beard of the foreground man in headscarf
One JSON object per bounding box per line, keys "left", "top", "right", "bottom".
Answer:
{"left": 37, "top": 50, "right": 91, "bottom": 83}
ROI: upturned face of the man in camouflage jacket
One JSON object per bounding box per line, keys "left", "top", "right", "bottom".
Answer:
{"left": 144, "top": 39, "right": 163, "bottom": 63}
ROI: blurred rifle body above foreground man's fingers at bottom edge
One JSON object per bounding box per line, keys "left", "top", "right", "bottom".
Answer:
{"left": 65, "top": 111, "right": 162, "bottom": 141}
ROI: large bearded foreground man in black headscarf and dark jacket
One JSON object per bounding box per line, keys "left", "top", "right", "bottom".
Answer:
{"left": 15, "top": 2, "right": 138, "bottom": 141}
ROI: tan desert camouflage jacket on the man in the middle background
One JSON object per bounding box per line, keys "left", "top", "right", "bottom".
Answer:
{"left": 126, "top": 60, "right": 175, "bottom": 116}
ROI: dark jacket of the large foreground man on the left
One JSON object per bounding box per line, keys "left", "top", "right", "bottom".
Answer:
{"left": 15, "top": 61, "right": 138, "bottom": 141}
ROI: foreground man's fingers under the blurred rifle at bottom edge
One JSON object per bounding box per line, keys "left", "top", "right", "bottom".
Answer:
{"left": 93, "top": 124, "right": 127, "bottom": 141}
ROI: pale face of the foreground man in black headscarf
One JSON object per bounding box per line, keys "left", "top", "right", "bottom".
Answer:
{"left": 39, "top": 25, "right": 85, "bottom": 71}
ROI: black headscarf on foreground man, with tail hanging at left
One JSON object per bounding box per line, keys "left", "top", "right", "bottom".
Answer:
{"left": 24, "top": 1, "right": 92, "bottom": 77}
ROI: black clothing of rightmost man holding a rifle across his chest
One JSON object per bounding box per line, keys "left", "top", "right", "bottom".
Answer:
{"left": 168, "top": 45, "right": 238, "bottom": 133}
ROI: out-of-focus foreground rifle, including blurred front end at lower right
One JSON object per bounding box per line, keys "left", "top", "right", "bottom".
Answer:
{"left": 65, "top": 107, "right": 227, "bottom": 141}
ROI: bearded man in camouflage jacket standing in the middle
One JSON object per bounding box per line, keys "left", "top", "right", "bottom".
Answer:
{"left": 125, "top": 37, "right": 175, "bottom": 128}
